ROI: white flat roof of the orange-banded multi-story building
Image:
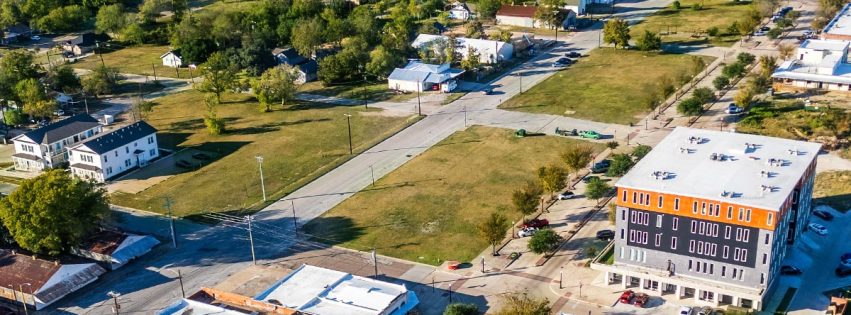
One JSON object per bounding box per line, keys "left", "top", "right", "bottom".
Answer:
{"left": 616, "top": 127, "right": 821, "bottom": 210}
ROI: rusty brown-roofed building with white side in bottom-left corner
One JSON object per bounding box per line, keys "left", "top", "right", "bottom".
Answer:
{"left": 0, "top": 249, "right": 106, "bottom": 310}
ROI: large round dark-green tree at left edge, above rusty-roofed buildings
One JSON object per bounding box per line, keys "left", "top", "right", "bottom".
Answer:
{"left": 0, "top": 169, "right": 109, "bottom": 255}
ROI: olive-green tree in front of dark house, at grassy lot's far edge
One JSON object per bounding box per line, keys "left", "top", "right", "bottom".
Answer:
{"left": 252, "top": 64, "right": 298, "bottom": 112}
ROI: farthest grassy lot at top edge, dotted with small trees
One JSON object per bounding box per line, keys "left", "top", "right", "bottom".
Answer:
{"left": 630, "top": 0, "right": 750, "bottom": 46}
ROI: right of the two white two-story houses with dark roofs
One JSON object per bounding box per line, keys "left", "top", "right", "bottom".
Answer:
{"left": 69, "top": 121, "right": 160, "bottom": 182}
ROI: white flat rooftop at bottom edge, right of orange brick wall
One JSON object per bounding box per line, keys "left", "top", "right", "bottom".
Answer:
{"left": 255, "top": 265, "right": 412, "bottom": 315}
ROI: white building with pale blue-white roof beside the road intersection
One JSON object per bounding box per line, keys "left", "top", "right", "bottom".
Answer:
{"left": 387, "top": 61, "right": 464, "bottom": 92}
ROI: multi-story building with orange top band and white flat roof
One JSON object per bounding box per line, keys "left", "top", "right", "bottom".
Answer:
{"left": 595, "top": 127, "right": 820, "bottom": 310}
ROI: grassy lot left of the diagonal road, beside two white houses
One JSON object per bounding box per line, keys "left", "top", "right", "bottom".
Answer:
{"left": 112, "top": 91, "right": 412, "bottom": 216}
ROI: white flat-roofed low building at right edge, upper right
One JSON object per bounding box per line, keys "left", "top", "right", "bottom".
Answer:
{"left": 771, "top": 39, "right": 851, "bottom": 91}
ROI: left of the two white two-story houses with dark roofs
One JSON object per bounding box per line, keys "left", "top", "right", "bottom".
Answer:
{"left": 12, "top": 114, "right": 103, "bottom": 171}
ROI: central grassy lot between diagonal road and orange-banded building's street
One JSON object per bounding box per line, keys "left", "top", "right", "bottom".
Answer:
{"left": 305, "top": 127, "right": 601, "bottom": 265}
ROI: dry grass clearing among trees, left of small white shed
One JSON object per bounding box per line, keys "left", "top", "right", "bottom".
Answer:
{"left": 71, "top": 45, "right": 189, "bottom": 79}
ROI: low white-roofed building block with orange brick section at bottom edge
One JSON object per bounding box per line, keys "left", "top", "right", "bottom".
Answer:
{"left": 157, "top": 265, "right": 419, "bottom": 315}
